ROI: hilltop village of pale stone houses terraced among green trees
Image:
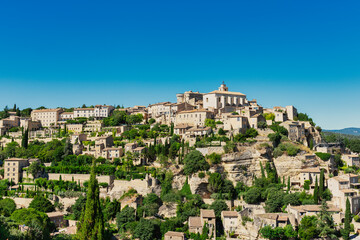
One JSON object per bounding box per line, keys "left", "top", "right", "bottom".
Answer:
{"left": 0, "top": 83, "right": 360, "bottom": 240}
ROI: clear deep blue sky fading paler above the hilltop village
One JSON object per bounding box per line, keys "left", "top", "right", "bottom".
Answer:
{"left": 0, "top": 0, "right": 360, "bottom": 129}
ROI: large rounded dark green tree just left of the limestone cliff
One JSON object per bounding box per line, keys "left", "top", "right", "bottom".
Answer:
{"left": 184, "top": 150, "right": 210, "bottom": 175}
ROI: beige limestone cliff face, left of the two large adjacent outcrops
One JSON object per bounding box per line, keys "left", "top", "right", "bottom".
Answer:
{"left": 221, "top": 143, "right": 271, "bottom": 186}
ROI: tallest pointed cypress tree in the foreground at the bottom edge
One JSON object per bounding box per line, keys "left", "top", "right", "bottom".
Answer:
{"left": 78, "top": 161, "right": 105, "bottom": 240}
